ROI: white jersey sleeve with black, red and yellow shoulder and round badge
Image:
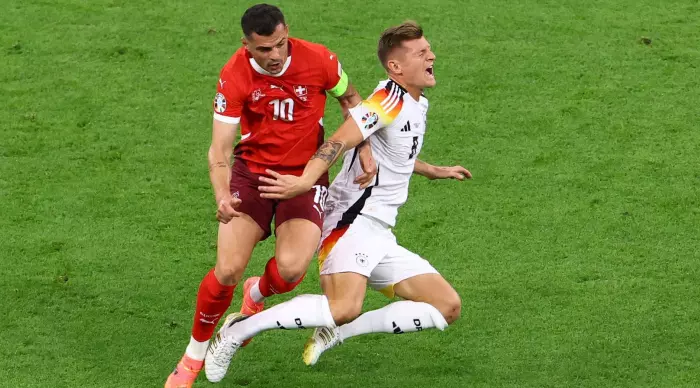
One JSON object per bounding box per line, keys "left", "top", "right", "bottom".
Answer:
{"left": 350, "top": 88, "right": 403, "bottom": 139}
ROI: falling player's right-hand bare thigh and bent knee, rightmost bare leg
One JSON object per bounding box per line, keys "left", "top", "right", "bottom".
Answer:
{"left": 394, "top": 273, "right": 462, "bottom": 323}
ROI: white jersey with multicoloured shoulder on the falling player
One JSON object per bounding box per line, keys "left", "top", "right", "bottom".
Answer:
{"left": 323, "top": 80, "right": 428, "bottom": 230}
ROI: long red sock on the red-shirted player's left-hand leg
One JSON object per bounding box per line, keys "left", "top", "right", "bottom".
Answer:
{"left": 192, "top": 269, "right": 236, "bottom": 342}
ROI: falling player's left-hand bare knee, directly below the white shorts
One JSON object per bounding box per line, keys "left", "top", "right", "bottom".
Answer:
{"left": 321, "top": 272, "right": 367, "bottom": 325}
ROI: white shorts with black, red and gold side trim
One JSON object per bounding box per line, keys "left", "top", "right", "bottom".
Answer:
{"left": 318, "top": 215, "right": 438, "bottom": 298}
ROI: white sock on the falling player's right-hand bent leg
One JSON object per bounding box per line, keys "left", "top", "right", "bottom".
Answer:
{"left": 339, "top": 300, "right": 447, "bottom": 341}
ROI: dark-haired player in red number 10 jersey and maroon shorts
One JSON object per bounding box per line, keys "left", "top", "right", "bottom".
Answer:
{"left": 165, "top": 4, "right": 376, "bottom": 388}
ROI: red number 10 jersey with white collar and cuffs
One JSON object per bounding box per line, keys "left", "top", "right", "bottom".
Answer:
{"left": 214, "top": 38, "right": 342, "bottom": 175}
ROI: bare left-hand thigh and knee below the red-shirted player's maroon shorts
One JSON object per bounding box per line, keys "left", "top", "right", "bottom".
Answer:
{"left": 214, "top": 213, "right": 264, "bottom": 285}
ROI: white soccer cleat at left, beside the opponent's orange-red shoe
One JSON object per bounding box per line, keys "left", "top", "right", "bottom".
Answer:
{"left": 204, "top": 313, "right": 247, "bottom": 383}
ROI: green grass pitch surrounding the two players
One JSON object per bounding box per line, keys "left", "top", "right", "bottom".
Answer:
{"left": 0, "top": 0, "right": 700, "bottom": 388}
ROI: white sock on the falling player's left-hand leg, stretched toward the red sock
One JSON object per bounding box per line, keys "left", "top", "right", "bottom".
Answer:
{"left": 226, "top": 295, "right": 335, "bottom": 342}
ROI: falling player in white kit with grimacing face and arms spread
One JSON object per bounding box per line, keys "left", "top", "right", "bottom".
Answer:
{"left": 205, "top": 22, "right": 471, "bottom": 382}
